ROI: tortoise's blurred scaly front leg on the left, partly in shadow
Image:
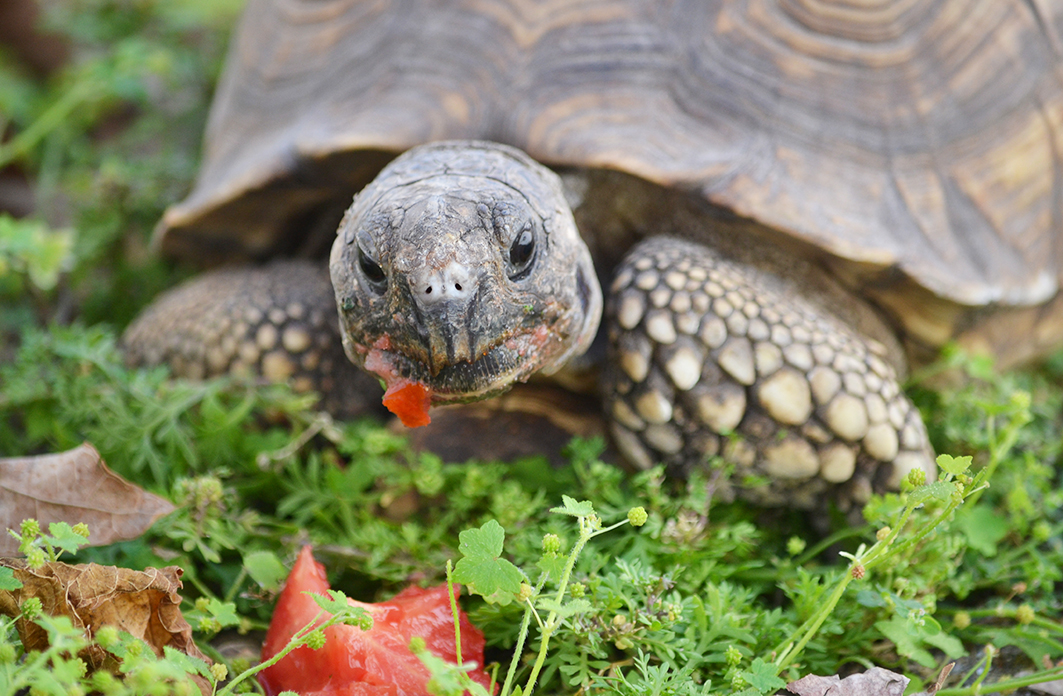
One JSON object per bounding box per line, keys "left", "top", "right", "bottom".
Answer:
{"left": 122, "top": 261, "right": 381, "bottom": 417}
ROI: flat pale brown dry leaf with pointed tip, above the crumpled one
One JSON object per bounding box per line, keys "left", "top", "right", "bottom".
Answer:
{"left": 0, "top": 443, "right": 173, "bottom": 556}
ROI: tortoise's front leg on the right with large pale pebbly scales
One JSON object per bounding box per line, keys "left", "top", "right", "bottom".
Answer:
{"left": 604, "top": 237, "right": 934, "bottom": 508}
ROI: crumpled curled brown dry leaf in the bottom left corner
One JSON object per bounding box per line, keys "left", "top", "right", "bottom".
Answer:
{"left": 0, "top": 559, "right": 210, "bottom": 693}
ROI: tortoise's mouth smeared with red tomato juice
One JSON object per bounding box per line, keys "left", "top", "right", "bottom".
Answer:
{"left": 362, "top": 326, "right": 557, "bottom": 404}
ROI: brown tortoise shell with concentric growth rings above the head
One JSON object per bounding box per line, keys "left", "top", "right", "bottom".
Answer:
{"left": 157, "top": 0, "right": 1063, "bottom": 362}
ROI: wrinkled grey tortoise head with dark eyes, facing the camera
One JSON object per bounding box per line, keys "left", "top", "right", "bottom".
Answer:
{"left": 330, "top": 141, "right": 602, "bottom": 403}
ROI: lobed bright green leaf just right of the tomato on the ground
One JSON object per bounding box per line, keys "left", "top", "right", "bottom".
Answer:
{"left": 454, "top": 520, "right": 524, "bottom": 605}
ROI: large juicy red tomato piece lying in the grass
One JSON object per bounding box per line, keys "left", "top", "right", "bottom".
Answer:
{"left": 258, "top": 546, "right": 490, "bottom": 696}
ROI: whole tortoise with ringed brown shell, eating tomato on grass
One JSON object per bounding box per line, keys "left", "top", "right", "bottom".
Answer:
{"left": 124, "top": 0, "right": 1063, "bottom": 508}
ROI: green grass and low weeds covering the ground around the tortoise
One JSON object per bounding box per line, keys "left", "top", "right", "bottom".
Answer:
{"left": 0, "top": 0, "right": 1063, "bottom": 696}
